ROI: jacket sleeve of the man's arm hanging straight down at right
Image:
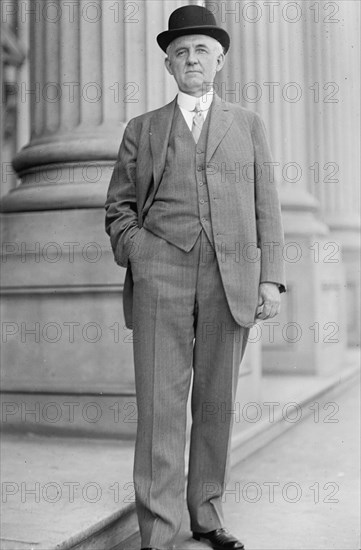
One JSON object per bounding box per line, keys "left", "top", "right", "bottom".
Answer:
{"left": 252, "top": 113, "right": 286, "bottom": 292}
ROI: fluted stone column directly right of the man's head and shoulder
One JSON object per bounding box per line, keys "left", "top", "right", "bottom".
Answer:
{"left": 209, "top": 0, "right": 327, "bottom": 234}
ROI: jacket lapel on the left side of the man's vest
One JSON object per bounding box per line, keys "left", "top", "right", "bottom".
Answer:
{"left": 149, "top": 97, "right": 177, "bottom": 194}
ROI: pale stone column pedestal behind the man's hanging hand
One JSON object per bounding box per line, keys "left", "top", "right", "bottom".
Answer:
{"left": 260, "top": 191, "right": 346, "bottom": 375}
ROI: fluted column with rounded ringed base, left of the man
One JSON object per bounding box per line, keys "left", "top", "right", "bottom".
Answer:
{"left": 4, "top": 0, "right": 116, "bottom": 211}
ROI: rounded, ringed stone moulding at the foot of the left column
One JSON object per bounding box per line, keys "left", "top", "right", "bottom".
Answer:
{"left": 1, "top": 130, "right": 125, "bottom": 212}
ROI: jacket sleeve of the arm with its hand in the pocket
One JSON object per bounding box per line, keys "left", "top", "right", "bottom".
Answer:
{"left": 105, "top": 119, "right": 139, "bottom": 267}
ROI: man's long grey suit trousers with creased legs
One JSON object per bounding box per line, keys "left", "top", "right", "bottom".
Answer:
{"left": 130, "top": 228, "right": 249, "bottom": 550}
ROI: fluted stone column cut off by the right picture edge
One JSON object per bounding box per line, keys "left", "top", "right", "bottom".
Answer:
{"left": 312, "top": 1, "right": 360, "bottom": 230}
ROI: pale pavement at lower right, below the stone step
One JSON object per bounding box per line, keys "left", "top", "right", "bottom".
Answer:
{"left": 172, "top": 384, "right": 361, "bottom": 550}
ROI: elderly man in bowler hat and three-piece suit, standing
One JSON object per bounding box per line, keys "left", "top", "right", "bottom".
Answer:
{"left": 106, "top": 5, "right": 285, "bottom": 550}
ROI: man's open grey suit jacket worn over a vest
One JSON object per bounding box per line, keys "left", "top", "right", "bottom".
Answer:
{"left": 105, "top": 95, "right": 285, "bottom": 328}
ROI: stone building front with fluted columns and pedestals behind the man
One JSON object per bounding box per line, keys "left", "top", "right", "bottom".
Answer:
{"left": 1, "top": 0, "right": 360, "bottom": 438}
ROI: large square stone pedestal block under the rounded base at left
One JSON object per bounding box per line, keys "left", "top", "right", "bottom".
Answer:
{"left": 1, "top": 209, "right": 136, "bottom": 437}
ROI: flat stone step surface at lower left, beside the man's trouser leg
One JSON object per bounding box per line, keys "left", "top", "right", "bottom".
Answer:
{"left": 1, "top": 434, "right": 134, "bottom": 550}
